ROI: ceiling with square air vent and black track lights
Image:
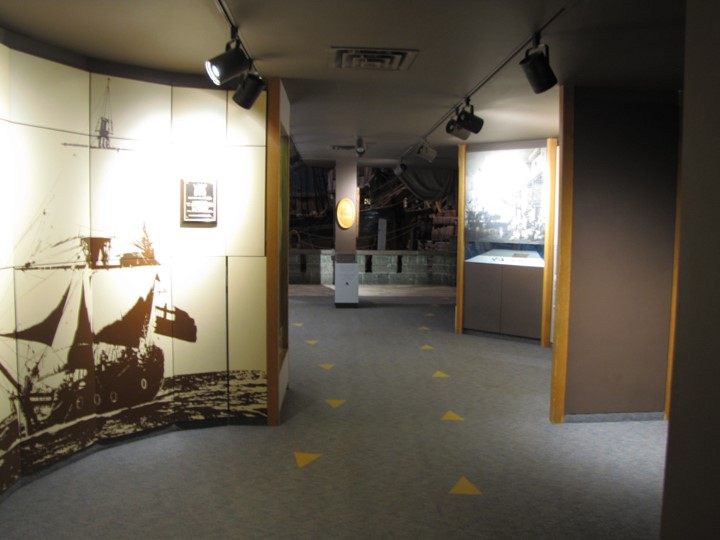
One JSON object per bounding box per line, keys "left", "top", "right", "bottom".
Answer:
{"left": 0, "top": 0, "right": 685, "bottom": 165}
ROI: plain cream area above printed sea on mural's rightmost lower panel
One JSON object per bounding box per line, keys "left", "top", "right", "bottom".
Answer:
{"left": 228, "top": 257, "right": 267, "bottom": 371}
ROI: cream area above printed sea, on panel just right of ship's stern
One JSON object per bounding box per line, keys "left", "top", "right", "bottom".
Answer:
{"left": 172, "top": 257, "right": 227, "bottom": 375}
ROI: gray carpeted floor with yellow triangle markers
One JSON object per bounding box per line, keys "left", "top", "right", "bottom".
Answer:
{"left": 0, "top": 288, "right": 667, "bottom": 539}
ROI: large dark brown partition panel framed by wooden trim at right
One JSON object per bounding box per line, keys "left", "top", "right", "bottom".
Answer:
{"left": 566, "top": 88, "right": 679, "bottom": 414}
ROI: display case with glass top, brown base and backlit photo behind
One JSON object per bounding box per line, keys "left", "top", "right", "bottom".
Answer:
{"left": 463, "top": 142, "right": 549, "bottom": 338}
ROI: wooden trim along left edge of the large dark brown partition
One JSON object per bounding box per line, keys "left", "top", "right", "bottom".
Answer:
{"left": 550, "top": 86, "right": 575, "bottom": 424}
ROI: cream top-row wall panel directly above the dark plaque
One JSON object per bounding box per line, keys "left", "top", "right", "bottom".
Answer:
{"left": 172, "top": 88, "right": 227, "bottom": 150}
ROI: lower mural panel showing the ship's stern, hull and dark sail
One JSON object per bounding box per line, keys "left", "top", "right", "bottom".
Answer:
{"left": 92, "top": 264, "right": 180, "bottom": 439}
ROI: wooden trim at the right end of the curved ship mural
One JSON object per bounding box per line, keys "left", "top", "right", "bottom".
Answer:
{"left": 265, "top": 79, "right": 281, "bottom": 426}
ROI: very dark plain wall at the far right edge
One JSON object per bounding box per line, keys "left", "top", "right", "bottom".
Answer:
{"left": 661, "top": 0, "right": 720, "bottom": 540}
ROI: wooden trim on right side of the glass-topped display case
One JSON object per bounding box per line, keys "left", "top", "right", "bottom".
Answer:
{"left": 540, "top": 135, "right": 558, "bottom": 347}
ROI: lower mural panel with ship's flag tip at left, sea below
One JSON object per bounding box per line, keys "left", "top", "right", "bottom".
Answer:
{"left": 172, "top": 257, "right": 228, "bottom": 421}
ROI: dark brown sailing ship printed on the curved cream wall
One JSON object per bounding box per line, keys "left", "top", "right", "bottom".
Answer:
{"left": 0, "top": 226, "right": 197, "bottom": 436}
